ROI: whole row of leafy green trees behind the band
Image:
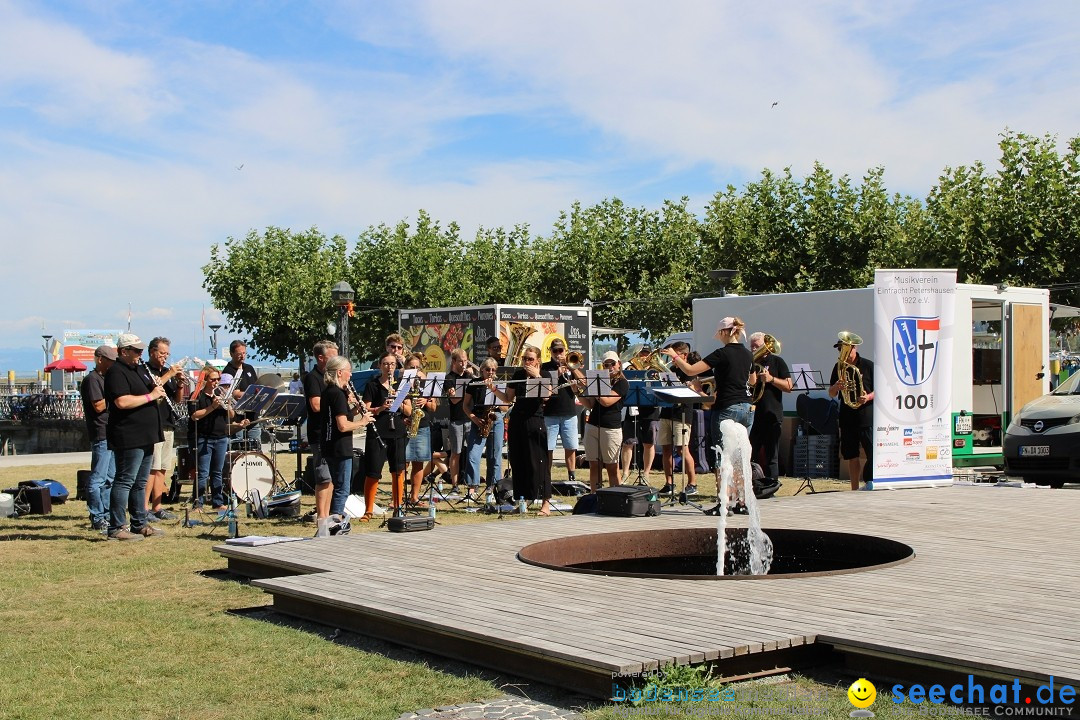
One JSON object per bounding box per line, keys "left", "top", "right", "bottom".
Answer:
{"left": 204, "top": 131, "right": 1080, "bottom": 359}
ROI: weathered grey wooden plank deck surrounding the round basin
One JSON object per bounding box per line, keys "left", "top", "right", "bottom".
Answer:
{"left": 216, "top": 487, "right": 1080, "bottom": 695}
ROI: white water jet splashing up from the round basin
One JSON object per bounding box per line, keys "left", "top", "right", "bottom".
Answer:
{"left": 716, "top": 420, "right": 772, "bottom": 575}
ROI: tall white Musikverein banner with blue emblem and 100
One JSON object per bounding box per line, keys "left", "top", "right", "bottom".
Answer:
{"left": 874, "top": 270, "right": 956, "bottom": 488}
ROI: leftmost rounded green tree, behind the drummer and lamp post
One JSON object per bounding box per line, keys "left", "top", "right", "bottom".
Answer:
{"left": 203, "top": 227, "right": 346, "bottom": 361}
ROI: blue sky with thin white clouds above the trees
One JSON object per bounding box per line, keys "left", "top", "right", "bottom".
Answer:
{"left": 0, "top": 0, "right": 1080, "bottom": 370}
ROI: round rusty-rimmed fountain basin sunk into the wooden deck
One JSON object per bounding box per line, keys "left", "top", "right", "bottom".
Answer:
{"left": 517, "top": 528, "right": 915, "bottom": 580}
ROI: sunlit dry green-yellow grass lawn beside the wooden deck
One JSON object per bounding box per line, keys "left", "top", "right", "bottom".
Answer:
{"left": 0, "top": 465, "right": 872, "bottom": 720}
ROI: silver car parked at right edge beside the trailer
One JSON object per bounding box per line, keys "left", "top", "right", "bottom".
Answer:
{"left": 1004, "top": 372, "right": 1080, "bottom": 488}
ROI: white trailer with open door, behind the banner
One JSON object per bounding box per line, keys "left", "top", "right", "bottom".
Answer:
{"left": 693, "top": 284, "right": 1050, "bottom": 472}
